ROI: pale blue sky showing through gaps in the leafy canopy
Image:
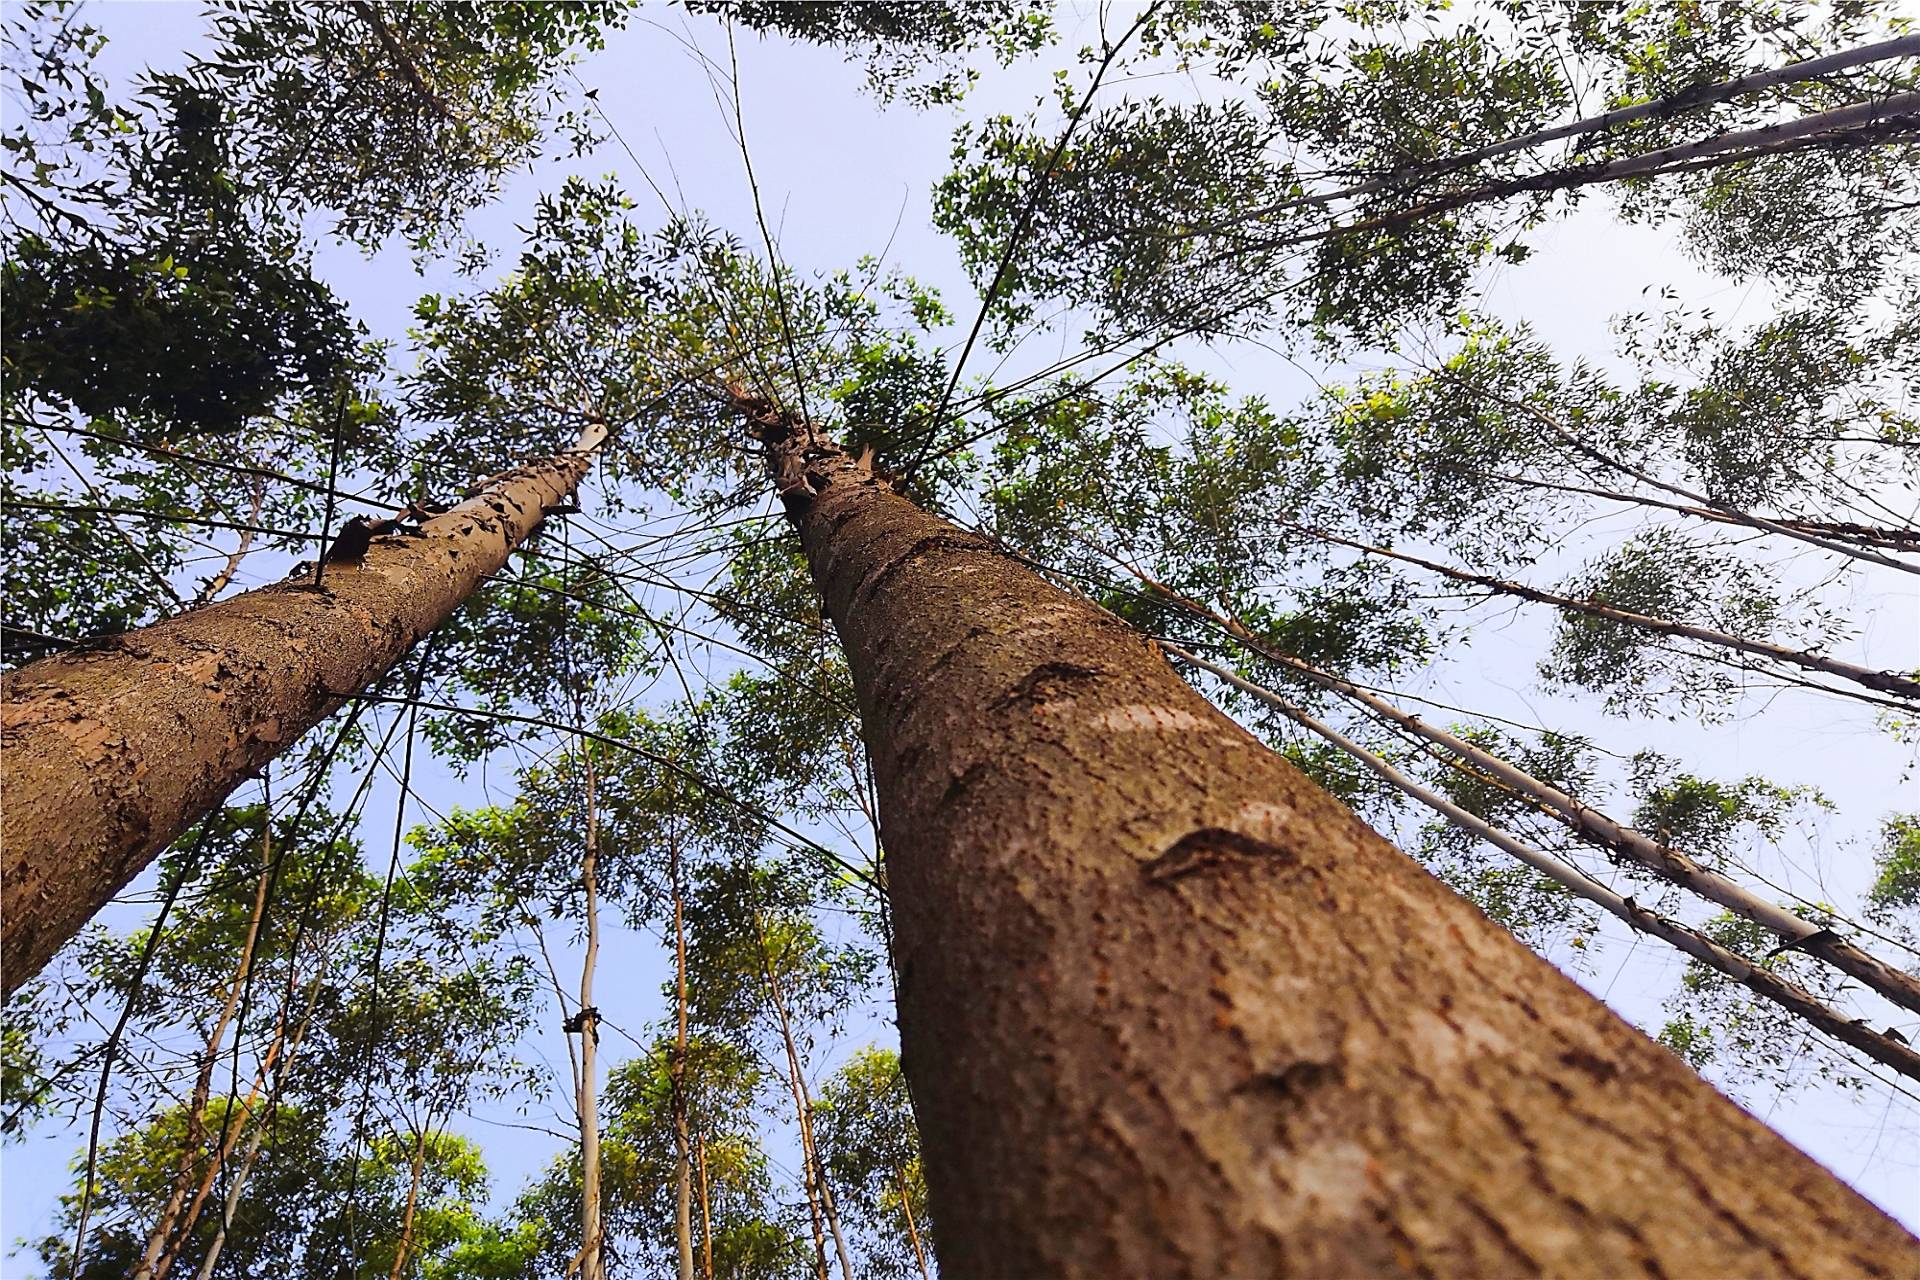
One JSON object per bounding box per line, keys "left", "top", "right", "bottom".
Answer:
{"left": 0, "top": 0, "right": 1920, "bottom": 1278}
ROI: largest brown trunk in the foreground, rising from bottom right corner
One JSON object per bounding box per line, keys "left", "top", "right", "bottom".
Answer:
{"left": 743, "top": 395, "right": 1920, "bottom": 1280}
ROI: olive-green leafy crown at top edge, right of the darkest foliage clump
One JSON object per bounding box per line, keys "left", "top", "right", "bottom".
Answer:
{"left": 196, "top": 0, "right": 632, "bottom": 251}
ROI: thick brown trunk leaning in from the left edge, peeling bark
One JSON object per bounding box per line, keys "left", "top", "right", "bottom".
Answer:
{"left": 0, "top": 422, "right": 607, "bottom": 996}
